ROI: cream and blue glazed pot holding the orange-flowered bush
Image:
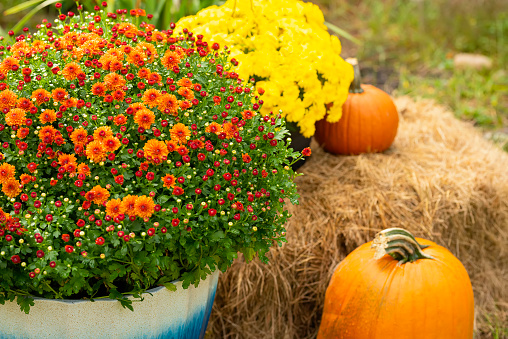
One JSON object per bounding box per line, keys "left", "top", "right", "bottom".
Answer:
{"left": 0, "top": 271, "right": 219, "bottom": 339}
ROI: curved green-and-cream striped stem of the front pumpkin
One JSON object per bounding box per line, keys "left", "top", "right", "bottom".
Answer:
{"left": 371, "top": 228, "right": 434, "bottom": 264}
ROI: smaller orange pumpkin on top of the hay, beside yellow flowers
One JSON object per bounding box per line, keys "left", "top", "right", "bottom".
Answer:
{"left": 315, "top": 58, "right": 399, "bottom": 155}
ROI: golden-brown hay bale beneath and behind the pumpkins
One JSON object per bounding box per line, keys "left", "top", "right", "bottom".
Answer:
{"left": 208, "top": 97, "right": 508, "bottom": 339}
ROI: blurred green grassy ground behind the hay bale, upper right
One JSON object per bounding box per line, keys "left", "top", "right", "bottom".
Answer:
{"left": 320, "top": 0, "right": 508, "bottom": 129}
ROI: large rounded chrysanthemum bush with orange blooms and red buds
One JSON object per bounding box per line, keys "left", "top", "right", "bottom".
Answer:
{"left": 0, "top": 2, "right": 310, "bottom": 312}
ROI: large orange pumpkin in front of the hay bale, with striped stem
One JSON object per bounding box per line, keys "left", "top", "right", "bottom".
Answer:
{"left": 317, "top": 228, "right": 474, "bottom": 339}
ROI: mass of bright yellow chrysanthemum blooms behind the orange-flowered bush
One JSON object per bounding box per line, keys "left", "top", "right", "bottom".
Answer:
{"left": 177, "top": 0, "right": 353, "bottom": 137}
